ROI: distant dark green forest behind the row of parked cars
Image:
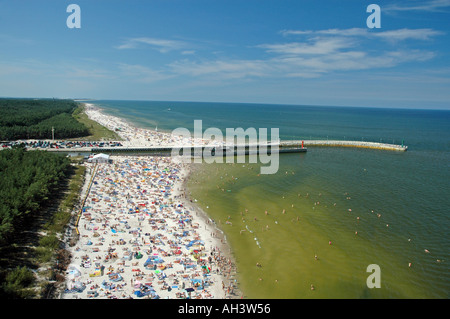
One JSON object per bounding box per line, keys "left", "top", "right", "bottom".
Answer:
{"left": 0, "top": 99, "right": 89, "bottom": 141}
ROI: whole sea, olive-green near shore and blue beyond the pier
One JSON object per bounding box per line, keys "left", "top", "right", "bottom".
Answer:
{"left": 95, "top": 101, "right": 450, "bottom": 298}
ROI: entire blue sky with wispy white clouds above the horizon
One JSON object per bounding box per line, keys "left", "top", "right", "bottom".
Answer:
{"left": 0, "top": 0, "right": 450, "bottom": 109}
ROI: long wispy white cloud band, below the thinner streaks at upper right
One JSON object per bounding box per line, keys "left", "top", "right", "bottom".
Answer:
{"left": 168, "top": 45, "right": 435, "bottom": 81}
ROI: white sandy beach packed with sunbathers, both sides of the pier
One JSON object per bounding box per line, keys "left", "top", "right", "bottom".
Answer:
{"left": 61, "top": 104, "right": 241, "bottom": 299}
